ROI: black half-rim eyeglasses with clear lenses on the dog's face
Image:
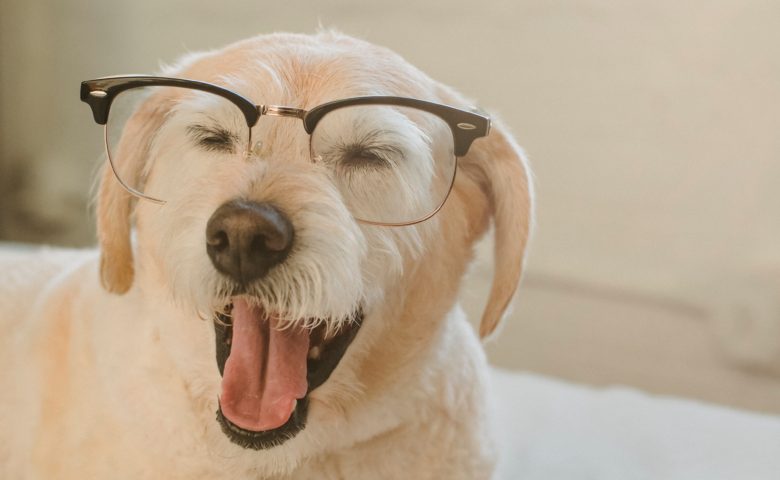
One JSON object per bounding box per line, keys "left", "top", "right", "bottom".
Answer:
{"left": 81, "top": 75, "right": 490, "bottom": 226}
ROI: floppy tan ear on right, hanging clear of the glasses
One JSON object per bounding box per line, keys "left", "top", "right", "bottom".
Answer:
{"left": 461, "top": 120, "right": 533, "bottom": 338}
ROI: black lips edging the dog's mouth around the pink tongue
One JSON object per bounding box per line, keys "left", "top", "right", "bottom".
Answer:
{"left": 214, "top": 309, "right": 363, "bottom": 450}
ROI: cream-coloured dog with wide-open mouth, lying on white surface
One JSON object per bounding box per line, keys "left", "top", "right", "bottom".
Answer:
{"left": 0, "top": 33, "right": 531, "bottom": 479}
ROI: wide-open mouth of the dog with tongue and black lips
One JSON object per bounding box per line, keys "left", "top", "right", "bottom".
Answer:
{"left": 214, "top": 297, "right": 363, "bottom": 450}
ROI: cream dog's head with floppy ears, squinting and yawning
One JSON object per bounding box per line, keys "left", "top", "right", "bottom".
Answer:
{"left": 90, "top": 33, "right": 531, "bottom": 463}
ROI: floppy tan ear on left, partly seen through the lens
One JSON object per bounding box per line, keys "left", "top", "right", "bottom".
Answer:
{"left": 97, "top": 98, "right": 166, "bottom": 294}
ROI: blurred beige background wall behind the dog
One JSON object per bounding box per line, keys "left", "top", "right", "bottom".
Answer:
{"left": 0, "top": 0, "right": 780, "bottom": 413}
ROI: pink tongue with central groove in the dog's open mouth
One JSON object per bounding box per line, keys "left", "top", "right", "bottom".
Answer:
{"left": 220, "top": 297, "right": 309, "bottom": 431}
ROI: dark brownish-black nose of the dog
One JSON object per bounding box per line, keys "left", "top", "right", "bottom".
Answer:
{"left": 206, "top": 200, "right": 294, "bottom": 284}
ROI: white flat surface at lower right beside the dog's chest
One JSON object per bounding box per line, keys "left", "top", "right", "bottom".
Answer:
{"left": 494, "top": 371, "right": 780, "bottom": 480}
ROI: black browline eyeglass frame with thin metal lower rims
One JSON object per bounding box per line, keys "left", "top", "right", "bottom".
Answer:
{"left": 80, "top": 75, "right": 490, "bottom": 226}
